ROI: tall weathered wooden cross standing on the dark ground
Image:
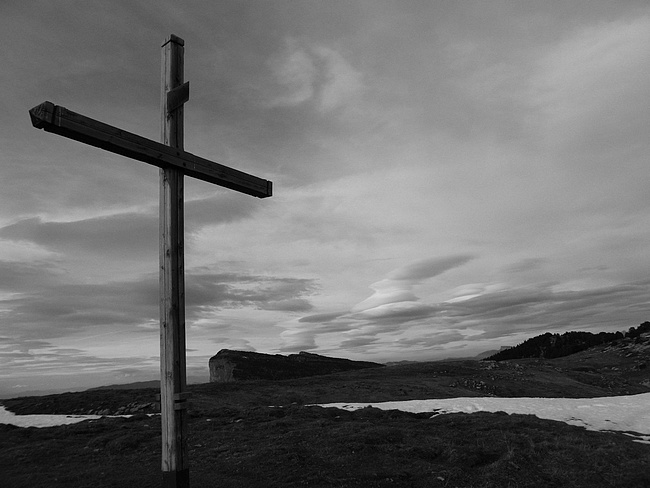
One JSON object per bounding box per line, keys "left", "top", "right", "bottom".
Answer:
{"left": 29, "top": 35, "right": 273, "bottom": 488}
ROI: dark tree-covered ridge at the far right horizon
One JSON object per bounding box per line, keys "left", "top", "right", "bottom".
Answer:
{"left": 484, "top": 322, "right": 650, "bottom": 361}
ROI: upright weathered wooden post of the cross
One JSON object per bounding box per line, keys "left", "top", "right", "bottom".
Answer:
{"left": 160, "top": 35, "right": 190, "bottom": 488}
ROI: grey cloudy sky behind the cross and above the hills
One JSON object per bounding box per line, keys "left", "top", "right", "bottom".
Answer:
{"left": 0, "top": 0, "right": 650, "bottom": 393}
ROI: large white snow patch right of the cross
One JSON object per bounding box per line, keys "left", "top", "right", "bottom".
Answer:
{"left": 319, "top": 393, "right": 650, "bottom": 444}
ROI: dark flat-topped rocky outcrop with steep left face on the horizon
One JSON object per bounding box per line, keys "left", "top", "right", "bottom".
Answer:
{"left": 209, "top": 349, "right": 384, "bottom": 383}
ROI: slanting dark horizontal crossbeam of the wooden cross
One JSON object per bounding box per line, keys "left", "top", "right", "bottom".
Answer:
{"left": 29, "top": 102, "right": 273, "bottom": 198}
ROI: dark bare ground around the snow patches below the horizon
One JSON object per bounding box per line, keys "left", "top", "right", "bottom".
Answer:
{"left": 0, "top": 350, "right": 650, "bottom": 488}
